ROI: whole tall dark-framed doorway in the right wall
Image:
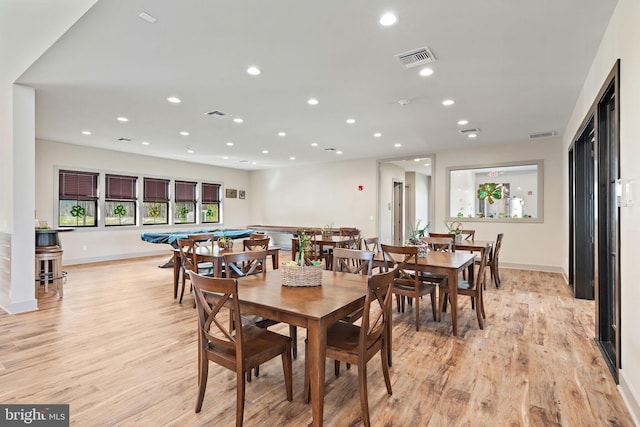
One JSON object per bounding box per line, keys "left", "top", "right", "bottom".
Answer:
{"left": 569, "top": 61, "right": 622, "bottom": 382}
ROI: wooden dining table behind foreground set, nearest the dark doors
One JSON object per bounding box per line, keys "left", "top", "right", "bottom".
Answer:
{"left": 373, "top": 251, "right": 475, "bottom": 338}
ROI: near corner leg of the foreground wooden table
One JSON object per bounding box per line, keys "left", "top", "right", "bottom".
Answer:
{"left": 307, "top": 321, "right": 327, "bottom": 427}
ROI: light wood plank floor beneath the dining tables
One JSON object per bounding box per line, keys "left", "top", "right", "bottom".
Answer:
{"left": 0, "top": 257, "right": 633, "bottom": 426}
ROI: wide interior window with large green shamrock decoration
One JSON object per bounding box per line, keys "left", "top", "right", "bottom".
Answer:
{"left": 447, "top": 160, "right": 544, "bottom": 222}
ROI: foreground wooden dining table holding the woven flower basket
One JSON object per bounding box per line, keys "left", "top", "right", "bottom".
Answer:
{"left": 222, "top": 270, "right": 368, "bottom": 426}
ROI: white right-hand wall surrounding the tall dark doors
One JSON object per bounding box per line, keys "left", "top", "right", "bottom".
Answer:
{"left": 561, "top": 0, "right": 640, "bottom": 423}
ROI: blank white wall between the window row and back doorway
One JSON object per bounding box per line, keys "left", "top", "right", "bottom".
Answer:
{"left": 249, "top": 160, "right": 378, "bottom": 244}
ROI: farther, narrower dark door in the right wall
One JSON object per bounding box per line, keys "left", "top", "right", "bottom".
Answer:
{"left": 573, "top": 117, "right": 596, "bottom": 299}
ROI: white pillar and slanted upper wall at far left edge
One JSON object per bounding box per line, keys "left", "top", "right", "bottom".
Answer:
{"left": 0, "top": 0, "right": 97, "bottom": 313}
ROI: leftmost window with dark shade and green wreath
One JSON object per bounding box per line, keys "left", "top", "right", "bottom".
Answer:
{"left": 58, "top": 170, "right": 98, "bottom": 227}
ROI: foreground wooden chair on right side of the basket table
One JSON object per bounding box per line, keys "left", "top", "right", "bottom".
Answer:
{"left": 304, "top": 270, "right": 396, "bottom": 426}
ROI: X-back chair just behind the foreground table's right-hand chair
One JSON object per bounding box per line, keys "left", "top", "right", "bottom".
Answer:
{"left": 380, "top": 244, "right": 436, "bottom": 331}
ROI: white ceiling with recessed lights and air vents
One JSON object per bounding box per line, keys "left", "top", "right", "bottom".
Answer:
{"left": 13, "top": 0, "right": 616, "bottom": 170}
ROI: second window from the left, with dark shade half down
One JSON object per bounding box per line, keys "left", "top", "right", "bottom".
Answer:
{"left": 104, "top": 174, "right": 138, "bottom": 226}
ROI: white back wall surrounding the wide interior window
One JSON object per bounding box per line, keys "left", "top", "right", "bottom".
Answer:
{"left": 429, "top": 138, "right": 568, "bottom": 272}
